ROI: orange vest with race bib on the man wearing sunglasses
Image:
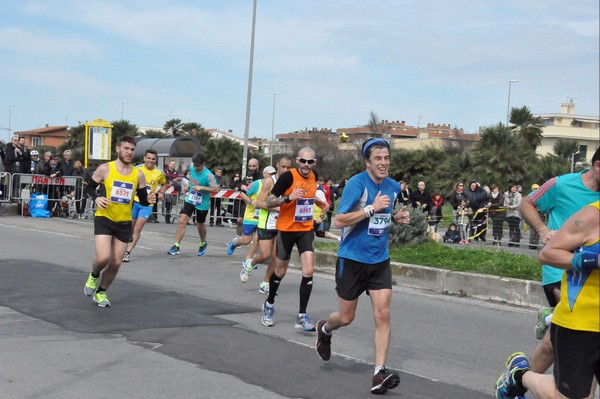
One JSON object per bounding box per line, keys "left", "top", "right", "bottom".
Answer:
{"left": 276, "top": 169, "right": 317, "bottom": 231}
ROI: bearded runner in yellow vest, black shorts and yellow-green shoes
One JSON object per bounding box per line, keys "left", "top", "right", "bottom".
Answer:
{"left": 83, "top": 136, "right": 156, "bottom": 308}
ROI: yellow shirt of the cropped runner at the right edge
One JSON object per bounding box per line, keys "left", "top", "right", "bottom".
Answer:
{"left": 552, "top": 201, "right": 600, "bottom": 332}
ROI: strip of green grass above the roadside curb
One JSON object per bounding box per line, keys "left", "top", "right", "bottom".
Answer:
{"left": 315, "top": 241, "right": 542, "bottom": 281}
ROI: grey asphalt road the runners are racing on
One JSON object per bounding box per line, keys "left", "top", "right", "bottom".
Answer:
{"left": 0, "top": 216, "right": 537, "bottom": 399}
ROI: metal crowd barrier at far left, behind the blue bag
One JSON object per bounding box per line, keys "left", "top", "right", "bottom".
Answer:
{"left": 11, "top": 173, "right": 84, "bottom": 217}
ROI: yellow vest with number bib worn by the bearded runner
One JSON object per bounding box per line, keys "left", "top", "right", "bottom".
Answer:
{"left": 96, "top": 161, "right": 139, "bottom": 222}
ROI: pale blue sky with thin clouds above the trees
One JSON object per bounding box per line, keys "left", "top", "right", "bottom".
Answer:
{"left": 0, "top": 0, "right": 600, "bottom": 145}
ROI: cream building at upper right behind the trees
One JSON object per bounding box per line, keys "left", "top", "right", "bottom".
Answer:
{"left": 534, "top": 99, "right": 600, "bottom": 162}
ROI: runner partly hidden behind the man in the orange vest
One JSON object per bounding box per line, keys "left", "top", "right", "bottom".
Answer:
{"left": 240, "top": 155, "right": 292, "bottom": 295}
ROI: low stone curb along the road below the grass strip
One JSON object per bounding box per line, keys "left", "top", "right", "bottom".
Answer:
{"left": 290, "top": 251, "right": 546, "bottom": 308}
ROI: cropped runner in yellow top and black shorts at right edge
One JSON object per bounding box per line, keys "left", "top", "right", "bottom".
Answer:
{"left": 494, "top": 201, "right": 600, "bottom": 399}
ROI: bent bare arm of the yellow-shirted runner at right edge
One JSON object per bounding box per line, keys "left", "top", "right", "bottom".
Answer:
{"left": 540, "top": 206, "right": 600, "bottom": 269}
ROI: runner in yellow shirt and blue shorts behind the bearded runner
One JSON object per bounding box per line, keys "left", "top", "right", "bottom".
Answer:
{"left": 123, "top": 149, "right": 168, "bottom": 262}
